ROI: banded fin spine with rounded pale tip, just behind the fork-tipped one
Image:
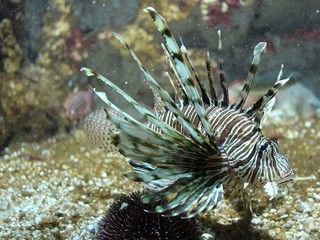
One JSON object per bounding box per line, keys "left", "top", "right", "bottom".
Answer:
{"left": 232, "top": 42, "right": 267, "bottom": 110}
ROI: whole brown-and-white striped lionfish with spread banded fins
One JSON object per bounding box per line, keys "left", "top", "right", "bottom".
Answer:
{"left": 81, "top": 7, "right": 294, "bottom": 218}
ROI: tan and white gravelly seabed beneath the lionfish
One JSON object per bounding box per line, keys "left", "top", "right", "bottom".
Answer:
{"left": 0, "top": 117, "right": 320, "bottom": 240}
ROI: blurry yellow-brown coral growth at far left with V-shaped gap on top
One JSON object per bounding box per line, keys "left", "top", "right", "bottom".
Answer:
{"left": 0, "top": 0, "right": 77, "bottom": 140}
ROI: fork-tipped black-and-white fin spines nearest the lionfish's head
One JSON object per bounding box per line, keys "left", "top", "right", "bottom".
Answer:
{"left": 244, "top": 64, "right": 291, "bottom": 125}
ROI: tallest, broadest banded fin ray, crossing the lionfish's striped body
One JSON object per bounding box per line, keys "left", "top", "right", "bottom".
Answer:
{"left": 145, "top": 7, "right": 218, "bottom": 147}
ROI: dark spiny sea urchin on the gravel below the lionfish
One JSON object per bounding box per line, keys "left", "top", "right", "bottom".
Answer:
{"left": 95, "top": 192, "right": 200, "bottom": 240}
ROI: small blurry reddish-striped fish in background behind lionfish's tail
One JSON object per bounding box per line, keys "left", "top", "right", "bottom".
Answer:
{"left": 63, "top": 89, "right": 93, "bottom": 127}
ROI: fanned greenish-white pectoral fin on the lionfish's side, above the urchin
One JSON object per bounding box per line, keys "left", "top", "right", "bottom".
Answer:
{"left": 84, "top": 71, "right": 227, "bottom": 217}
